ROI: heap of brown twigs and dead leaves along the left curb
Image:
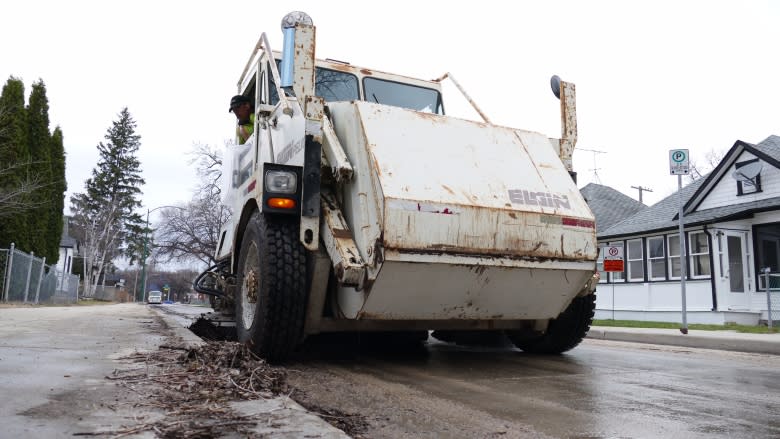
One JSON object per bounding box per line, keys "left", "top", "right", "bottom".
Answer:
{"left": 101, "top": 342, "right": 288, "bottom": 438}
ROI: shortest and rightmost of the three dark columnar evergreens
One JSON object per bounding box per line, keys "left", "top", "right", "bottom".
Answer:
{"left": 45, "top": 127, "right": 68, "bottom": 264}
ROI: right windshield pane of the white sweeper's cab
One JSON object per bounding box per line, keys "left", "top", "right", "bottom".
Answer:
{"left": 363, "top": 78, "right": 444, "bottom": 114}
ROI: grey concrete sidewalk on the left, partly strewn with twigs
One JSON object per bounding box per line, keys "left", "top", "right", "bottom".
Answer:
{"left": 0, "top": 303, "right": 348, "bottom": 439}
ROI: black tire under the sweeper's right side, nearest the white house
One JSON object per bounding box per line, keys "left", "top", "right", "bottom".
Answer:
{"left": 506, "top": 293, "right": 596, "bottom": 354}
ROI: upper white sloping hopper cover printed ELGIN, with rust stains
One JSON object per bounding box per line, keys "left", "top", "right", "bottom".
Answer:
{"left": 338, "top": 102, "right": 597, "bottom": 261}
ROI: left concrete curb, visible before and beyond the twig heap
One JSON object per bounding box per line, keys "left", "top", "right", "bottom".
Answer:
{"left": 149, "top": 307, "right": 349, "bottom": 439}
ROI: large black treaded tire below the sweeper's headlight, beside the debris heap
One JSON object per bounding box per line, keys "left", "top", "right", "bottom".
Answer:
{"left": 235, "top": 212, "right": 307, "bottom": 362}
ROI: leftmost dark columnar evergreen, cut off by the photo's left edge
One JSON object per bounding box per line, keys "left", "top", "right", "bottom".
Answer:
{"left": 0, "top": 77, "right": 30, "bottom": 251}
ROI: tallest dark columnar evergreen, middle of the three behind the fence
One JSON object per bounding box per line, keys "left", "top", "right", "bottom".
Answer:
{"left": 27, "top": 79, "right": 52, "bottom": 263}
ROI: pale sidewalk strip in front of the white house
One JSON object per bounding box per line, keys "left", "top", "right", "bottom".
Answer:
{"left": 587, "top": 326, "right": 780, "bottom": 355}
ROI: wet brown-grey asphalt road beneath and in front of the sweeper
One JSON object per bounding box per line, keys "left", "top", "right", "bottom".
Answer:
{"left": 158, "top": 306, "right": 780, "bottom": 439}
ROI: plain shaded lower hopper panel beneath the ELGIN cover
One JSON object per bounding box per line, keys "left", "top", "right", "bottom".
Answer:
{"left": 338, "top": 261, "right": 593, "bottom": 320}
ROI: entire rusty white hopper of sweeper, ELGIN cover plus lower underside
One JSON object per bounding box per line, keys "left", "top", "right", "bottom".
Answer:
{"left": 322, "top": 102, "right": 597, "bottom": 320}
